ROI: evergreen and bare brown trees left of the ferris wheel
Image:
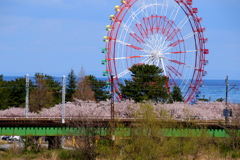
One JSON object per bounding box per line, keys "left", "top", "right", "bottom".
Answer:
{"left": 0, "top": 69, "right": 110, "bottom": 112}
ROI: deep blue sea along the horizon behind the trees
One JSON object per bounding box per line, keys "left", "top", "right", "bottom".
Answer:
{"left": 3, "top": 76, "right": 240, "bottom": 104}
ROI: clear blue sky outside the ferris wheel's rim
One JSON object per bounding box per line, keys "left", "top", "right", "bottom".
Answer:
{"left": 0, "top": 0, "right": 240, "bottom": 80}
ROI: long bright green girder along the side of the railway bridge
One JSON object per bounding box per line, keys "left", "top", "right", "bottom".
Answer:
{"left": 0, "top": 127, "right": 231, "bottom": 137}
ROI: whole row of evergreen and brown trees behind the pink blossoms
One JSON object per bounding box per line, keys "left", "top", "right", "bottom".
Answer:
{"left": 0, "top": 64, "right": 184, "bottom": 112}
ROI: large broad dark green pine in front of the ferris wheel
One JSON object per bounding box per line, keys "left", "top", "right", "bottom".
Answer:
{"left": 119, "top": 64, "right": 169, "bottom": 102}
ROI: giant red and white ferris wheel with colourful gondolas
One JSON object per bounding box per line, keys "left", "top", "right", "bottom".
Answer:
{"left": 102, "top": 0, "right": 209, "bottom": 102}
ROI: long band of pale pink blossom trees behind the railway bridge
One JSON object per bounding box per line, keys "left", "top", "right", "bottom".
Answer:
{"left": 0, "top": 99, "right": 240, "bottom": 120}
